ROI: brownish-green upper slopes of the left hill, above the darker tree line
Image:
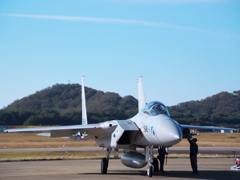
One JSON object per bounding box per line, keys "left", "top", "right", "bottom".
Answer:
{"left": 4, "top": 84, "right": 137, "bottom": 114}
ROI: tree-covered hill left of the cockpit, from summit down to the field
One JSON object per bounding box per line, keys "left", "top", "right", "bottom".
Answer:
{"left": 0, "top": 84, "right": 137, "bottom": 125}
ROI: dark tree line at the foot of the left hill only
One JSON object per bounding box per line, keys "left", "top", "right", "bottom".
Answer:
{"left": 0, "top": 110, "right": 132, "bottom": 126}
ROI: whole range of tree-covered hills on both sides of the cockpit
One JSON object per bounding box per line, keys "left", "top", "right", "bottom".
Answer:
{"left": 0, "top": 84, "right": 240, "bottom": 127}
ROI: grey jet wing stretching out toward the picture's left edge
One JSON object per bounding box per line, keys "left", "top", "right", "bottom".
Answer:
{"left": 4, "top": 121, "right": 117, "bottom": 137}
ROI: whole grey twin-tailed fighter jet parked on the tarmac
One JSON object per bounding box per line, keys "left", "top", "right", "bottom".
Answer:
{"left": 5, "top": 77, "right": 234, "bottom": 177}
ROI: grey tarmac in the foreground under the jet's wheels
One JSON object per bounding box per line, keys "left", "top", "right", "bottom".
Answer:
{"left": 0, "top": 158, "right": 240, "bottom": 180}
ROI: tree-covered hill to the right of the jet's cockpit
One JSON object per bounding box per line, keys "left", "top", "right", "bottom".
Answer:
{"left": 169, "top": 91, "right": 240, "bottom": 127}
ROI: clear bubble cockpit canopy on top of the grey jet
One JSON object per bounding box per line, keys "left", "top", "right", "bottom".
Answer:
{"left": 142, "top": 101, "right": 170, "bottom": 116}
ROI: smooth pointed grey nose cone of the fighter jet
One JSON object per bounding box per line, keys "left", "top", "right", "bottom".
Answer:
{"left": 158, "top": 117, "right": 182, "bottom": 146}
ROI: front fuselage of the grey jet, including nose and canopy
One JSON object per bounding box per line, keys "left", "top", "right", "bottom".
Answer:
{"left": 131, "top": 101, "right": 182, "bottom": 147}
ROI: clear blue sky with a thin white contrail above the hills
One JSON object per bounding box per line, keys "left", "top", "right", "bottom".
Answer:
{"left": 0, "top": 0, "right": 240, "bottom": 109}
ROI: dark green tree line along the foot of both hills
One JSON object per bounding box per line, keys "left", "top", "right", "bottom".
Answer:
{"left": 0, "top": 110, "right": 240, "bottom": 127}
